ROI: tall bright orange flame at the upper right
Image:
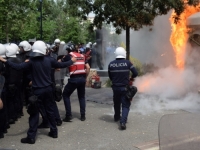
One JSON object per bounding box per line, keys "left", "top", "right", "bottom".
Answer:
{"left": 170, "top": 5, "right": 200, "bottom": 69}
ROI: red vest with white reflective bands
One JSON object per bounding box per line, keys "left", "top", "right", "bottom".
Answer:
{"left": 69, "top": 52, "right": 86, "bottom": 75}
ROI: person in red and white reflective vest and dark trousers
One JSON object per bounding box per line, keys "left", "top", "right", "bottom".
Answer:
{"left": 61, "top": 45, "right": 90, "bottom": 122}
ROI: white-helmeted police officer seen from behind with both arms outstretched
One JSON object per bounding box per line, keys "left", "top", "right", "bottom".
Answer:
{"left": 0, "top": 41, "right": 76, "bottom": 144}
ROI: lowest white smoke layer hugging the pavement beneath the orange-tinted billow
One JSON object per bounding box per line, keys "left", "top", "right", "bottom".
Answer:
{"left": 130, "top": 92, "right": 200, "bottom": 115}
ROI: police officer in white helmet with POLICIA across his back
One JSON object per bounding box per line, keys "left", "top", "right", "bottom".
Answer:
{"left": 108, "top": 47, "right": 138, "bottom": 130}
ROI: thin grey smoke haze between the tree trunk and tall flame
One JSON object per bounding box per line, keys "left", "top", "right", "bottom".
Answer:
{"left": 127, "top": 13, "right": 175, "bottom": 67}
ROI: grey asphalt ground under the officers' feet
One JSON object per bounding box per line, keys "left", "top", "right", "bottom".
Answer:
{"left": 0, "top": 88, "right": 191, "bottom": 150}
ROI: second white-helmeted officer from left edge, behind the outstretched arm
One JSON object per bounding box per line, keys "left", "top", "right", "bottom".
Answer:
{"left": 5, "top": 43, "right": 22, "bottom": 124}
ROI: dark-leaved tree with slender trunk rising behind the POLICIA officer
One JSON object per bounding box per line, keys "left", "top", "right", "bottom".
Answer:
{"left": 68, "top": 0, "right": 199, "bottom": 59}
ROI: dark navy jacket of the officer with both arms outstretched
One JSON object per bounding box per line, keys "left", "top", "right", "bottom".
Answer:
{"left": 6, "top": 55, "right": 73, "bottom": 88}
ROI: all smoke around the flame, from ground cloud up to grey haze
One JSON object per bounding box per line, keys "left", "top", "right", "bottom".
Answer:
{"left": 119, "top": 13, "right": 200, "bottom": 114}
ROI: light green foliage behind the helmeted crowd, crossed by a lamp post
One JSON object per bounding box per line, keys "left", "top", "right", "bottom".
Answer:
{"left": 0, "top": 0, "right": 93, "bottom": 43}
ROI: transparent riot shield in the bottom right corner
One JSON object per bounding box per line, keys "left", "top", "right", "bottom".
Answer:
{"left": 158, "top": 113, "right": 200, "bottom": 150}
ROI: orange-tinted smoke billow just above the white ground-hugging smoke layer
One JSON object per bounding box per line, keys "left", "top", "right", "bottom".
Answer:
{"left": 135, "top": 66, "right": 198, "bottom": 98}
